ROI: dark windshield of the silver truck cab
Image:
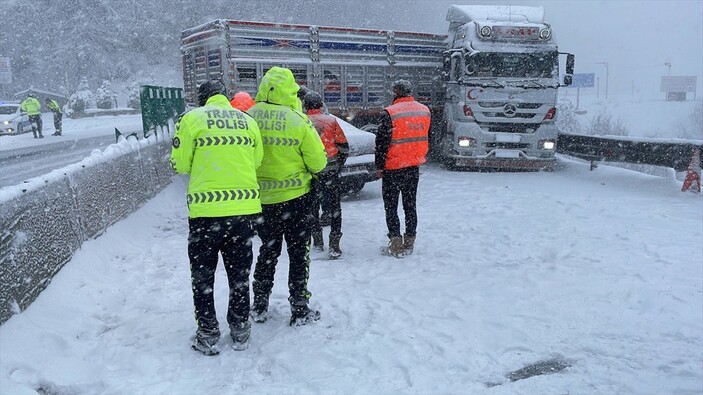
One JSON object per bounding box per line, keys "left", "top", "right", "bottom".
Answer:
{"left": 466, "top": 52, "right": 558, "bottom": 78}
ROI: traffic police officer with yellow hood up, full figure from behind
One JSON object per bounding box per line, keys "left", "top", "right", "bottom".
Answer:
{"left": 248, "top": 67, "right": 327, "bottom": 325}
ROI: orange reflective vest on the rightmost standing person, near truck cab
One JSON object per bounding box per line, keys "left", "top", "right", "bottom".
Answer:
{"left": 385, "top": 96, "right": 430, "bottom": 170}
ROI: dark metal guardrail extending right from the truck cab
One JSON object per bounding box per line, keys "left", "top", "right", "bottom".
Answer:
{"left": 557, "top": 133, "right": 703, "bottom": 171}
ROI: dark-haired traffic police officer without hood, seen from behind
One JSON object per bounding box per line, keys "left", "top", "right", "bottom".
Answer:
{"left": 171, "top": 80, "right": 264, "bottom": 355}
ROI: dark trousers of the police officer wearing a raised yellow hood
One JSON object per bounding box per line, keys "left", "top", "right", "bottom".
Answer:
{"left": 252, "top": 193, "right": 313, "bottom": 310}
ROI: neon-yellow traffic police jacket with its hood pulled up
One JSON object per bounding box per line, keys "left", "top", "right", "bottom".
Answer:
{"left": 247, "top": 67, "right": 327, "bottom": 204}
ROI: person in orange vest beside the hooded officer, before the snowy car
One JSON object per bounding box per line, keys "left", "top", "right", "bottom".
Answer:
{"left": 303, "top": 91, "right": 349, "bottom": 259}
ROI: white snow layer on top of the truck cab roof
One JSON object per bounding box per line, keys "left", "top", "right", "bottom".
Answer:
{"left": 447, "top": 4, "right": 544, "bottom": 24}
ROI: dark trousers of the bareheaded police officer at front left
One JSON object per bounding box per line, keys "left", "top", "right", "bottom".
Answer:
{"left": 188, "top": 216, "right": 254, "bottom": 334}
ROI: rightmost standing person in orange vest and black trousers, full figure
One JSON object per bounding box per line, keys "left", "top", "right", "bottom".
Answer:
{"left": 376, "top": 80, "right": 430, "bottom": 258}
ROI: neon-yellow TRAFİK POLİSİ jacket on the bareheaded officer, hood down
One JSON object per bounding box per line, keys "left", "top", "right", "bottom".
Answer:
{"left": 171, "top": 94, "right": 264, "bottom": 218}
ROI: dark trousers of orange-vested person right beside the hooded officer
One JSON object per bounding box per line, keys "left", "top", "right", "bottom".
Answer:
{"left": 313, "top": 171, "right": 342, "bottom": 234}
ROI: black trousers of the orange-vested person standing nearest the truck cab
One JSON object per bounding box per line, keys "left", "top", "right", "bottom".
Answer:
{"left": 381, "top": 166, "right": 420, "bottom": 237}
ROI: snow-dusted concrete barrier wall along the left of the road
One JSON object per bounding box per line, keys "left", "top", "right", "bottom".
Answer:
{"left": 0, "top": 135, "right": 174, "bottom": 324}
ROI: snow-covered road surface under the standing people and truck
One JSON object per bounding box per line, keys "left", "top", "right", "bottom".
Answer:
{"left": 0, "top": 159, "right": 703, "bottom": 394}
